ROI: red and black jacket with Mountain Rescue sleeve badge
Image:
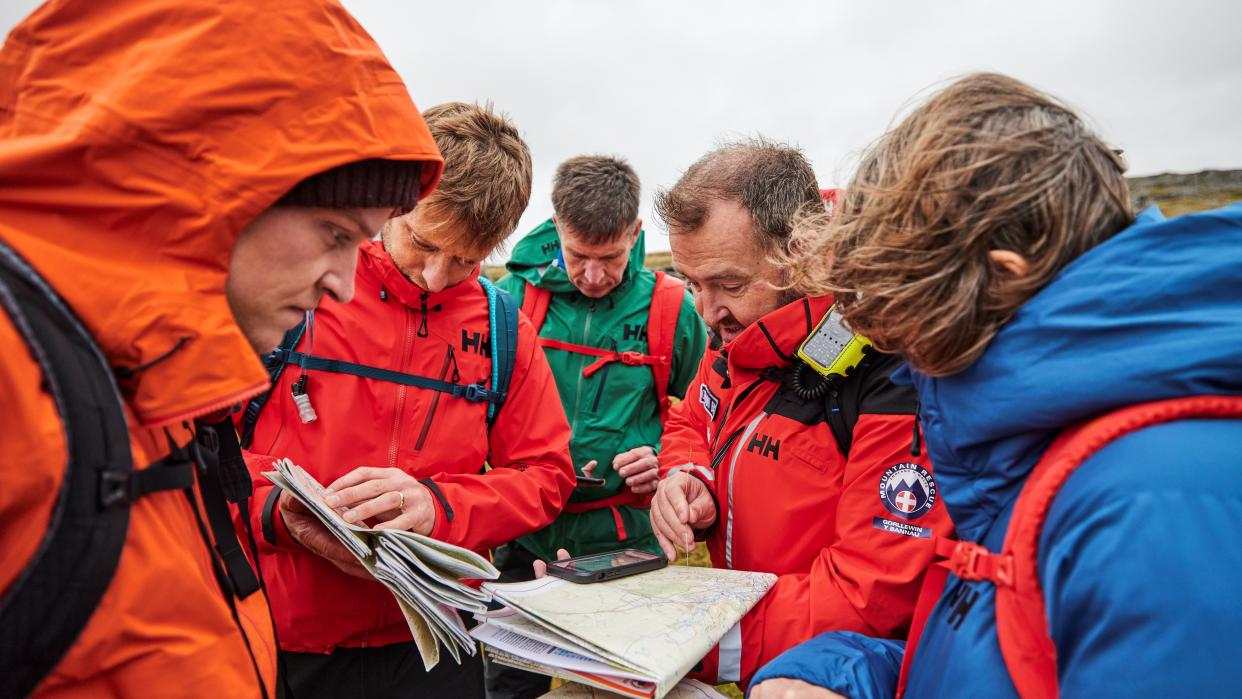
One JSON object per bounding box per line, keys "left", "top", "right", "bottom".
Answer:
{"left": 660, "top": 297, "right": 953, "bottom": 684}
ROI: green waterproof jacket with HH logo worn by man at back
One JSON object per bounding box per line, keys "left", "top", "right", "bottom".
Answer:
{"left": 499, "top": 220, "right": 707, "bottom": 560}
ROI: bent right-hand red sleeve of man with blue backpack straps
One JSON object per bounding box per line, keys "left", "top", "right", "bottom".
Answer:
{"left": 431, "top": 317, "right": 574, "bottom": 550}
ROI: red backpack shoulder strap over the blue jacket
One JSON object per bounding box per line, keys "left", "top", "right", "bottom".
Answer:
{"left": 996, "top": 396, "right": 1242, "bottom": 697}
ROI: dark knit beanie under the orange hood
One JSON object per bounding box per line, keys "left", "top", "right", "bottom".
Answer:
{"left": 276, "top": 160, "right": 422, "bottom": 212}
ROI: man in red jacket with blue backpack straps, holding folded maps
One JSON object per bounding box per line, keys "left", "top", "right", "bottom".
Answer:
{"left": 234, "top": 103, "right": 574, "bottom": 699}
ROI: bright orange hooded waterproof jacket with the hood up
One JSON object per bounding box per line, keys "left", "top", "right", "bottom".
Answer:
{"left": 0, "top": 0, "right": 441, "bottom": 697}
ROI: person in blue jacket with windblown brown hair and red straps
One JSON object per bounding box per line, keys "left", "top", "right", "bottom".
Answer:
{"left": 750, "top": 74, "right": 1242, "bottom": 699}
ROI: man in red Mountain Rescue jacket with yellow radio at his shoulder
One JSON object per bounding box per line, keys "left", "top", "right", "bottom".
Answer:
{"left": 651, "top": 140, "right": 951, "bottom": 685}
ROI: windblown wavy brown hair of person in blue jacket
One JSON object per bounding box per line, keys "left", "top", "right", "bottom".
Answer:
{"left": 785, "top": 73, "right": 1134, "bottom": 376}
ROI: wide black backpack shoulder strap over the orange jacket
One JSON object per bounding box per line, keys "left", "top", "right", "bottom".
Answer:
{"left": 0, "top": 242, "right": 140, "bottom": 697}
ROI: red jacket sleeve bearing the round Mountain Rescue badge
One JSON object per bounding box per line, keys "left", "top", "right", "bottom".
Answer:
{"left": 720, "top": 413, "right": 953, "bottom": 683}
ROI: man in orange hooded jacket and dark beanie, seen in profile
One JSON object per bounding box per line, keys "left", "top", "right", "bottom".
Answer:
{"left": 0, "top": 0, "right": 441, "bottom": 697}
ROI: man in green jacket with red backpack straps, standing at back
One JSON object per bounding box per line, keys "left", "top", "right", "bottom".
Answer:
{"left": 488, "top": 155, "right": 707, "bottom": 699}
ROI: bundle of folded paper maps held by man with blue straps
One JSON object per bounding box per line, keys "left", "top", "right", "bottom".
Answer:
{"left": 263, "top": 458, "right": 501, "bottom": 670}
